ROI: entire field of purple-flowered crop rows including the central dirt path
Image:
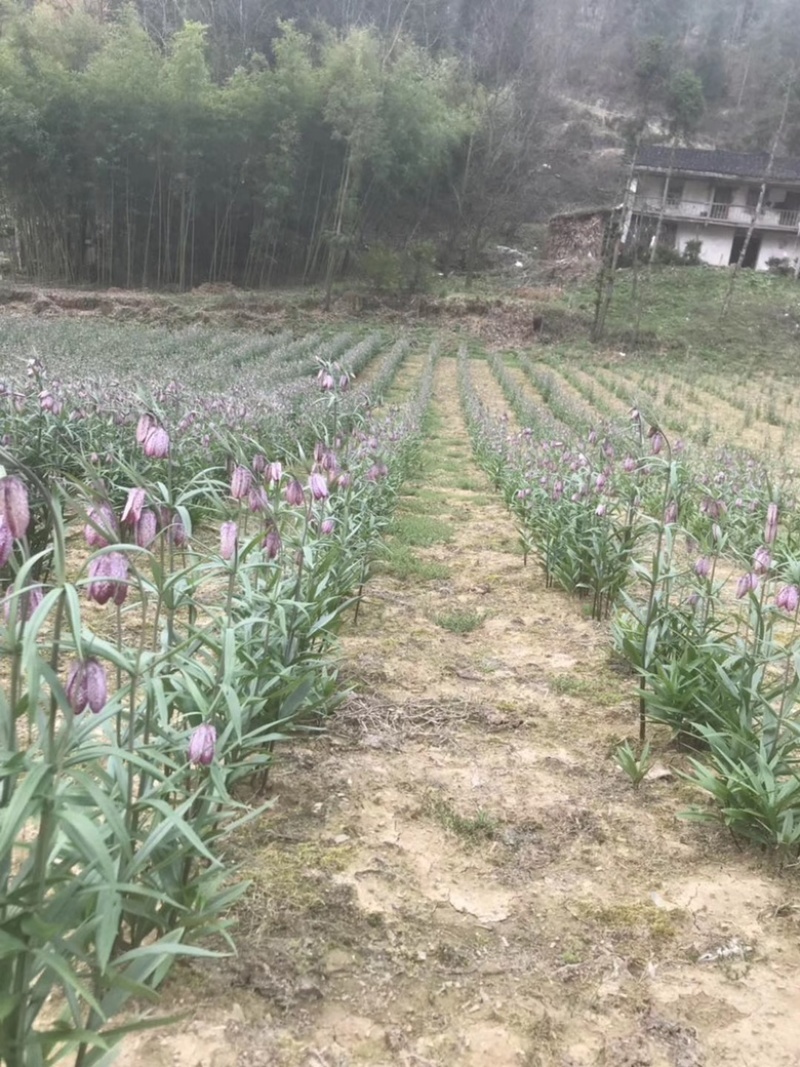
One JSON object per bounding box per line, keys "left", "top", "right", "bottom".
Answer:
{"left": 0, "top": 268, "right": 800, "bottom": 1067}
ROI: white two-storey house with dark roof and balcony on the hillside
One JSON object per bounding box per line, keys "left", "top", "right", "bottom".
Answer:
{"left": 626, "top": 145, "right": 800, "bottom": 270}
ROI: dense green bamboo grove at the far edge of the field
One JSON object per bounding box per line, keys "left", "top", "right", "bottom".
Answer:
{"left": 0, "top": 7, "right": 475, "bottom": 289}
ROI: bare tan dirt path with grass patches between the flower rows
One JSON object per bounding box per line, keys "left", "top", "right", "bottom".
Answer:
{"left": 118, "top": 359, "right": 800, "bottom": 1067}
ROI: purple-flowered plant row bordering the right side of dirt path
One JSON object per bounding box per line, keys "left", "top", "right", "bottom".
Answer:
{"left": 461, "top": 349, "right": 800, "bottom": 854}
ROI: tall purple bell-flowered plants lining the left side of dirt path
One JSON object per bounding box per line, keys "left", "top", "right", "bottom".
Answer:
{"left": 0, "top": 330, "right": 430, "bottom": 1067}
